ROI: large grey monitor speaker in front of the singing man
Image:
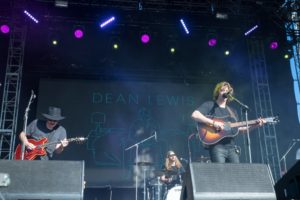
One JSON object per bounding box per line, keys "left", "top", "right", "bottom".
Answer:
{"left": 181, "top": 163, "right": 276, "bottom": 200}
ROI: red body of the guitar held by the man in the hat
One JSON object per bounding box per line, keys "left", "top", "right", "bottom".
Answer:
{"left": 14, "top": 138, "right": 48, "bottom": 160}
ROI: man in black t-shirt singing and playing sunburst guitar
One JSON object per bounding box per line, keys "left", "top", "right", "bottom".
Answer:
{"left": 191, "top": 81, "right": 265, "bottom": 163}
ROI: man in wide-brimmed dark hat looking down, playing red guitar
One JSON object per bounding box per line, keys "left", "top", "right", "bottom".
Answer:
{"left": 19, "top": 106, "right": 68, "bottom": 160}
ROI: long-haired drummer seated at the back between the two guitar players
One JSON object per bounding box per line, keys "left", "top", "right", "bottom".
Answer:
{"left": 160, "top": 151, "right": 185, "bottom": 190}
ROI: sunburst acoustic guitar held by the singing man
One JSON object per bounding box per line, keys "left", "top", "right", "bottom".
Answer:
{"left": 197, "top": 117, "right": 279, "bottom": 145}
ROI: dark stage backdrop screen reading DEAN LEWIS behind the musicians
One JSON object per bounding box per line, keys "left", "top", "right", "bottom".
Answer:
{"left": 37, "top": 79, "right": 259, "bottom": 186}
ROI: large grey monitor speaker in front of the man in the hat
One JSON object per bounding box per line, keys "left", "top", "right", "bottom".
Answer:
{"left": 0, "top": 160, "right": 84, "bottom": 200}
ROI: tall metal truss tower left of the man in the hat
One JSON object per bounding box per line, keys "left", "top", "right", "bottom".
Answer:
{"left": 0, "top": 2, "right": 27, "bottom": 159}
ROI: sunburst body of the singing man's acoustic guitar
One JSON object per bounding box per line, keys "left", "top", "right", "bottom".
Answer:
{"left": 198, "top": 118, "right": 238, "bottom": 145}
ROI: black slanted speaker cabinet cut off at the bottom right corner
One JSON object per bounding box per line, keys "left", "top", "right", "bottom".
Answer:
{"left": 275, "top": 161, "right": 300, "bottom": 200}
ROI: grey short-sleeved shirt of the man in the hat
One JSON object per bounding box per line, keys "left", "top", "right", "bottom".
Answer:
{"left": 26, "top": 119, "right": 67, "bottom": 157}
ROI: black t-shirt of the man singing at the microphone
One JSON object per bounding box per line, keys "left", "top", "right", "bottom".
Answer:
{"left": 197, "top": 101, "right": 238, "bottom": 144}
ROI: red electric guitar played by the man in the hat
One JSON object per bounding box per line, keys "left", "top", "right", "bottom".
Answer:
{"left": 14, "top": 137, "right": 88, "bottom": 160}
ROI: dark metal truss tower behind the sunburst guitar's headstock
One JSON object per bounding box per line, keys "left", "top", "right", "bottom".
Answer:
{"left": 247, "top": 38, "right": 281, "bottom": 180}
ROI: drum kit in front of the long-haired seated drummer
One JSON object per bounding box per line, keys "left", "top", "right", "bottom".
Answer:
{"left": 137, "top": 162, "right": 182, "bottom": 200}
